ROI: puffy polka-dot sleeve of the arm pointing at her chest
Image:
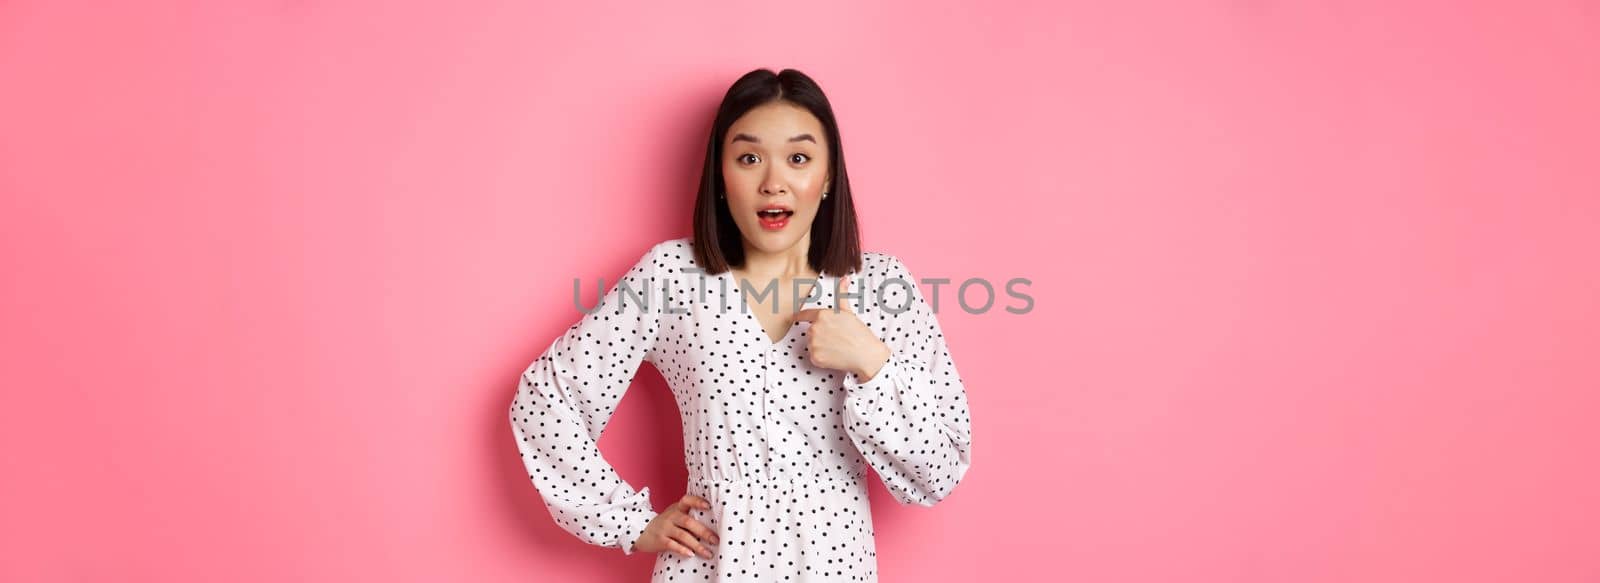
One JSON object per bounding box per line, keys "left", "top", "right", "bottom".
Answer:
{"left": 843, "top": 256, "right": 973, "bottom": 506}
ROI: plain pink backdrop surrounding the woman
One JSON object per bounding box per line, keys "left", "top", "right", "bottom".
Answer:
{"left": 0, "top": 0, "right": 1600, "bottom": 583}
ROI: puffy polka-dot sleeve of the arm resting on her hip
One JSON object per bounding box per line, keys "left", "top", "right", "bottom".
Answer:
{"left": 510, "top": 243, "right": 664, "bottom": 554}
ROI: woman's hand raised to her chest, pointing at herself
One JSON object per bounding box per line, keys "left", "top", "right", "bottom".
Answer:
{"left": 795, "top": 275, "right": 890, "bottom": 383}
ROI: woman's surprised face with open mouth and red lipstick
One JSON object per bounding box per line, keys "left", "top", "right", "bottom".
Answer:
{"left": 722, "top": 101, "right": 832, "bottom": 253}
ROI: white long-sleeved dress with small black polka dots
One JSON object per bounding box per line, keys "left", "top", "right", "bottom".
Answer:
{"left": 510, "top": 239, "right": 973, "bottom": 581}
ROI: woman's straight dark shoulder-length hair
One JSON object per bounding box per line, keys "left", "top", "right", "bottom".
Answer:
{"left": 694, "top": 69, "right": 861, "bottom": 275}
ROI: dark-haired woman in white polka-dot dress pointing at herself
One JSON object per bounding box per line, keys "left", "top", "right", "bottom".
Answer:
{"left": 510, "top": 69, "right": 971, "bottom": 581}
